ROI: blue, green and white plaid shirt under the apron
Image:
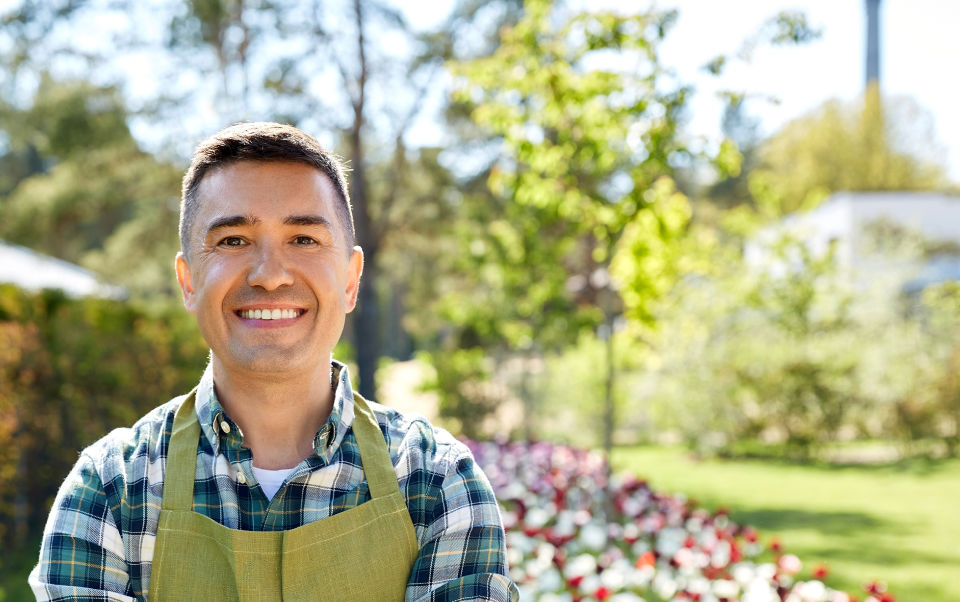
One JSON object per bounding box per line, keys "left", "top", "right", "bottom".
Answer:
{"left": 30, "top": 362, "right": 517, "bottom": 600}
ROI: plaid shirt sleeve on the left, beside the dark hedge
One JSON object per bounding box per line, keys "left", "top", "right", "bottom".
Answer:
{"left": 29, "top": 454, "right": 135, "bottom": 600}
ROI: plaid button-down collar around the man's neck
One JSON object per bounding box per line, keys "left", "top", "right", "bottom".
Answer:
{"left": 196, "top": 360, "right": 354, "bottom": 462}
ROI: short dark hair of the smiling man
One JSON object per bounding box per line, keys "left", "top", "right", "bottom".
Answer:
{"left": 180, "top": 122, "right": 355, "bottom": 255}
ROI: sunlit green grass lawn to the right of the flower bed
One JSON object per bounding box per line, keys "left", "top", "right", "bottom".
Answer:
{"left": 613, "top": 447, "right": 960, "bottom": 602}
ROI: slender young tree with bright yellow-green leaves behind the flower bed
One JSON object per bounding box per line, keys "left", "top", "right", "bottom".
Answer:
{"left": 446, "top": 1, "right": 689, "bottom": 449}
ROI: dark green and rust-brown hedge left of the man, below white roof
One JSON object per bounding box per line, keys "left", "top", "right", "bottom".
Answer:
{"left": 0, "top": 285, "right": 207, "bottom": 541}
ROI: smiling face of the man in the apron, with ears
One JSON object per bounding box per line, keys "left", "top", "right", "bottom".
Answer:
{"left": 177, "top": 161, "right": 363, "bottom": 376}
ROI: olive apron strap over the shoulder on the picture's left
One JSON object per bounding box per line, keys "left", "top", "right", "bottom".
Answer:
{"left": 160, "top": 389, "right": 200, "bottom": 510}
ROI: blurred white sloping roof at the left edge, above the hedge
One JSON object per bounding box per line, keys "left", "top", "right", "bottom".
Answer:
{"left": 0, "top": 242, "right": 126, "bottom": 299}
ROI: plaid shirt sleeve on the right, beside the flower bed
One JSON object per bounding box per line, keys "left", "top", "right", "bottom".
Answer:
{"left": 406, "top": 446, "right": 518, "bottom": 602}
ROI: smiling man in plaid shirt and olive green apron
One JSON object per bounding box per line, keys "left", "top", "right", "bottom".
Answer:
{"left": 30, "top": 123, "right": 517, "bottom": 600}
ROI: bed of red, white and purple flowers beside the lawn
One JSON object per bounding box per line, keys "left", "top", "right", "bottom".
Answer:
{"left": 466, "top": 441, "right": 894, "bottom": 602}
